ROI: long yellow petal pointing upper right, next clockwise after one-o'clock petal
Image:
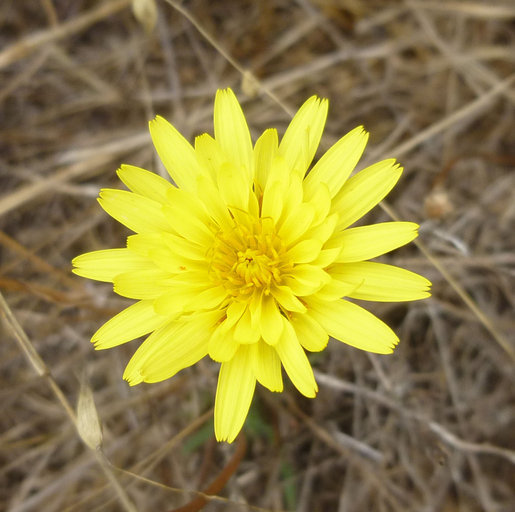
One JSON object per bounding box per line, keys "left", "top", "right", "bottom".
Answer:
{"left": 304, "top": 126, "right": 368, "bottom": 198}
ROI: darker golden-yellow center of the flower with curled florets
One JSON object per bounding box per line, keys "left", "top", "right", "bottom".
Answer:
{"left": 210, "top": 218, "right": 292, "bottom": 298}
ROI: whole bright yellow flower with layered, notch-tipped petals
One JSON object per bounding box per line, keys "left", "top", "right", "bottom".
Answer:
{"left": 73, "top": 89, "right": 431, "bottom": 442}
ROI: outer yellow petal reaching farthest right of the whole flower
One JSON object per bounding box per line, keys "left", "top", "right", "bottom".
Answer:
{"left": 330, "top": 261, "right": 431, "bottom": 302}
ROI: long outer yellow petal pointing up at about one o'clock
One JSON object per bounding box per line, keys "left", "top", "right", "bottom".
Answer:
{"left": 279, "top": 96, "right": 329, "bottom": 176}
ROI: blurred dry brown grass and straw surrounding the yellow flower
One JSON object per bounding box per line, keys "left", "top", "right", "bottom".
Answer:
{"left": 0, "top": 0, "right": 515, "bottom": 512}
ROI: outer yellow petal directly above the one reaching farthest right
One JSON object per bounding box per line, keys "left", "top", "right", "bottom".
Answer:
{"left": 329, "top": 222, "right": 418, "bottom": 263}
